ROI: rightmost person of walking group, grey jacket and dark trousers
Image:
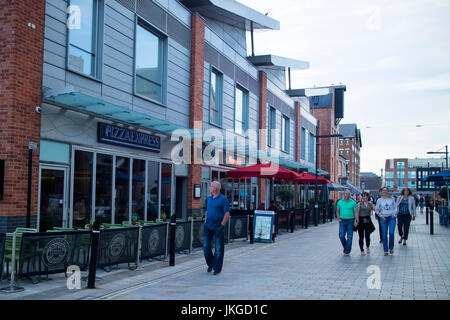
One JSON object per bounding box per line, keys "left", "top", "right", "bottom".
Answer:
{"left": 397, "top": 188, "right": 416, "bottom": 246}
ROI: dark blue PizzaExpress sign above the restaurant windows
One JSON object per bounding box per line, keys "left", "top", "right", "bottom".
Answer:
{"left": 98, "top": 122, "right": 161, "bottom": 152}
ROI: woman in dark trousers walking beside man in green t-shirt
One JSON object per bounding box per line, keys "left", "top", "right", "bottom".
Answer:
{"left": 357, "top": 192, "right": 375, "bottom": 256}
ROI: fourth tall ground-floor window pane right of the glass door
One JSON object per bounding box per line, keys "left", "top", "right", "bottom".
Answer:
{"left": 131, "top": 159, "right": 145, "bottom": 222}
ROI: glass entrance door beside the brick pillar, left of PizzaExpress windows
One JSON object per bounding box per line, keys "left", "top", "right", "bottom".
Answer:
{"left": 39, "top": 166, "right": 67, "bottom": 232}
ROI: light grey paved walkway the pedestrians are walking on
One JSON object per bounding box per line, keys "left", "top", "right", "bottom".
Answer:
{"left": 0, "top": 211, "right": 450, "bottom": 300}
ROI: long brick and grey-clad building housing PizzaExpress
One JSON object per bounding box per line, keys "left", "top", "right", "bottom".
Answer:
{"left": 0, "top": 0, "right": 345, "bottom": 231}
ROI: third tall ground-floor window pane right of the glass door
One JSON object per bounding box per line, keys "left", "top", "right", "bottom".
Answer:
{"left": 114, "top": 157, "right": 130, "bottom": 224}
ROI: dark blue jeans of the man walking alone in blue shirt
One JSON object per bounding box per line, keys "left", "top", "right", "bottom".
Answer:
{"left": 203, "top": 225, "right": 225, "bottom": 272}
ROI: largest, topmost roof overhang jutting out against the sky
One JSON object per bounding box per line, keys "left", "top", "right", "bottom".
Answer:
{"left": 180, "top": 0, "right": 280, "bottom": 31}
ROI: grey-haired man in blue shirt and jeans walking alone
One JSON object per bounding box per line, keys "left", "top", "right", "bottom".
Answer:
{"left": 203, "top": 181, "right": 230, "bottom": 275}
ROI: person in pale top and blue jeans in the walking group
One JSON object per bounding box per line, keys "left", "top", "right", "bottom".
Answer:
{"left": 375, "top": 187, "right": 397, "bottom": 256}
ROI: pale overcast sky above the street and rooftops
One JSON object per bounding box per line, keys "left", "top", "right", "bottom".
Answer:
{"left": 239, "top": 0, "right": 450, "bottom": 174}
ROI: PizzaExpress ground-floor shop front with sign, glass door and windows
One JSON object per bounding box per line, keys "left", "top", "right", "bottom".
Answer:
{"left": 37, "top": 96, "right": 187, "bottom": 231}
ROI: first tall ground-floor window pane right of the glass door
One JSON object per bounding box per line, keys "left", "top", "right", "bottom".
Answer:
{"left": 72, "top": 150, "right": 94, "bottom": 228}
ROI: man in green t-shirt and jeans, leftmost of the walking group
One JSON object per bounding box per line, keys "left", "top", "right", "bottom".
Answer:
{"left": 336, "top": 189, "right": 359, "bottom": 256}
